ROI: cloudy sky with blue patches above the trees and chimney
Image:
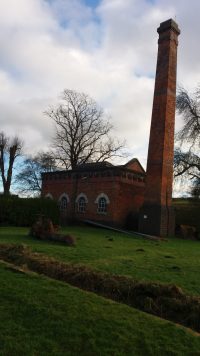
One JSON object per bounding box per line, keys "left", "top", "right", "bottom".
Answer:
{"left": 0, "top": 0, "right": 200, "bottom": 170}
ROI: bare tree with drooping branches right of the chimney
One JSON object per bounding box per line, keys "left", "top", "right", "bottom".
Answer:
{"left": 174, "top": 86, "right": 200, "bottom": 194}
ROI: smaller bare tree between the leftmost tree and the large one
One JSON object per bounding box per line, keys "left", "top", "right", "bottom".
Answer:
{"left": 15, "top": 152, "right": 56, "bottom": 196}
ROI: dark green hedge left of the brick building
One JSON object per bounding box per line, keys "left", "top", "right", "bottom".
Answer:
{"left": 0, "top": 196, "right": 59, "bottom": 226}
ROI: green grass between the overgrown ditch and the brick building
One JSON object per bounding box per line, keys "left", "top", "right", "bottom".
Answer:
{"left": 0, "top": 227, "right": 200, "bottom": 295}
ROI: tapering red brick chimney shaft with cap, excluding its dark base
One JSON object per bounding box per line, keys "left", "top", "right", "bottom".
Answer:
{"left": 145, "top": 20, "right": 179, "bottom": 206}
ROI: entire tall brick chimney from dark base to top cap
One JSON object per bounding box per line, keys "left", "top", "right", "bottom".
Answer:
{"left": 139, "top": 19, "right": 180, "bottom": 236}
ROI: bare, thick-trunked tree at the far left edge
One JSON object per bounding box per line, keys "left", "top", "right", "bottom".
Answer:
{"left": 0, "top": 132, "right": 23, "bottom": 195}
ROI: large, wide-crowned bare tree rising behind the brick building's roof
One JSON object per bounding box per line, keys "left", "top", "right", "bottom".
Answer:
{"left": 46, "top": 89, "right": 124, "bottom": 169}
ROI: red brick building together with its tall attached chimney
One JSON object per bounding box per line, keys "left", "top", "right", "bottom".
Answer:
{"left": 42, "top": 19, "right": 180, "bottom": 236}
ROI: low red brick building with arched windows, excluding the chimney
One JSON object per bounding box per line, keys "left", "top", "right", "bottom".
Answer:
{"left": 42, "top": 159, "right": 145, "bottom": 226}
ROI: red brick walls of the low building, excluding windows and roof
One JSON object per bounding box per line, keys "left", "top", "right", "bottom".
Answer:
{"left": 42, "top": 171, "right": 144, "bottom": 226}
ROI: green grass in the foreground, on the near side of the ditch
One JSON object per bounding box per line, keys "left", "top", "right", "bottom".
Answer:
{"left": 0, "top": 264, "right": 200, "bottom": 356}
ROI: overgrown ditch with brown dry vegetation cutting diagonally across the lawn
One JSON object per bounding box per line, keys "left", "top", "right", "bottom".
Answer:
{"left": 0, "top": 244, "right": 200, "bottom": 332}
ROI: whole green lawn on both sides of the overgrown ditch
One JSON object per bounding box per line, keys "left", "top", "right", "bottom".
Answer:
{"left": 0, "top": 227, "right": 200, "bottom": 356}
